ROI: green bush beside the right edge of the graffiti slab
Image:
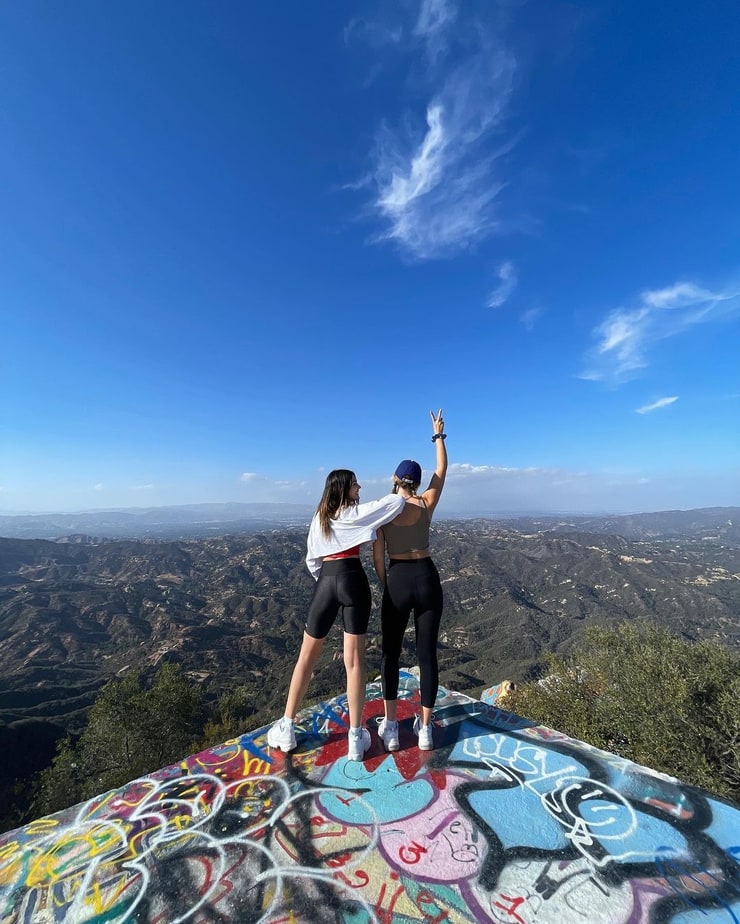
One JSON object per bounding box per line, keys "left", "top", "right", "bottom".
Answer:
{"left": 506, "top": 623, "right": 740, "bottom": 801}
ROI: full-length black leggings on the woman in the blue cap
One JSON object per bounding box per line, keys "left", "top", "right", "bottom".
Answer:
{"left": 380, "top": 558, "right": 442, "bottom": 709}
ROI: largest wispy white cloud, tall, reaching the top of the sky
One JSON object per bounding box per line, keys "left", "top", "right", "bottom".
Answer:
{"left": 362, "top": 0, "right": 516, "bottom": 260}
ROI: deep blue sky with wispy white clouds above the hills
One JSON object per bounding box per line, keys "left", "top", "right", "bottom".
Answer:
{"left": 0, "top": 0, "right": 740, "bottom": 514}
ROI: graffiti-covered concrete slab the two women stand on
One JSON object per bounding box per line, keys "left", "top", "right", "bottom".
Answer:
{"left": 0, "top": 675, "right": 740, "bottom": 924}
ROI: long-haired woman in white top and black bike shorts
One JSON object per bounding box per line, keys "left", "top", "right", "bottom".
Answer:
{"left": 267, "top": 468, "right": 405, "bottom": 760}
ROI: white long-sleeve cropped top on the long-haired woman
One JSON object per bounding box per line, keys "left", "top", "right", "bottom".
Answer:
{"left": 306, "top": 494, "right": 406, "bottom": 581}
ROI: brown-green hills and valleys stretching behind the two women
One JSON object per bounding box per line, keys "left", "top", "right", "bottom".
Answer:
{"left": 0, "top": 508, "right": 740, "bottom": 730}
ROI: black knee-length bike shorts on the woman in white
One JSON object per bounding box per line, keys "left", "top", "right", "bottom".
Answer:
{"left": 306, "top": 558, "right": 372, "bottom": 638}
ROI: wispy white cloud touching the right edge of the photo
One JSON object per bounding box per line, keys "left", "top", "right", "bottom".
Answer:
{"left": 581, "top": 282, "right": 740, "bottom": 384}
